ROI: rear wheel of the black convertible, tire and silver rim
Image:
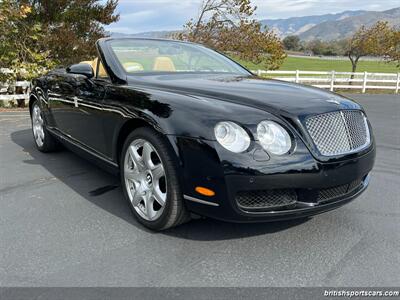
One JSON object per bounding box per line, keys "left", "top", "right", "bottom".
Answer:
{"left": 31, "top": 100, "right": 58, "bottom": 152}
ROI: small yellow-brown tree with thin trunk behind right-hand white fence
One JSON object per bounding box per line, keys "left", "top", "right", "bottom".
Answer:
{"left": 346, "top": 21, "right": 392, "bottom": 74}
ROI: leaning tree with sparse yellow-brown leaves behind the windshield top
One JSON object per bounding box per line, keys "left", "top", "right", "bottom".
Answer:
{"left": 175, "top": 0, "right": 286, "bottom": 69}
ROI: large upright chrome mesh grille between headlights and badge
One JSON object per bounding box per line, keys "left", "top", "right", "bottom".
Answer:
{"left": 306, "top": 110, "right": 370, "bottom": 156}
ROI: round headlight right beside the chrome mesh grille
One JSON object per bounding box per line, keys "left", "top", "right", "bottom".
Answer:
{"left": 257, "top": 121, "right": 292, "bottom": 155}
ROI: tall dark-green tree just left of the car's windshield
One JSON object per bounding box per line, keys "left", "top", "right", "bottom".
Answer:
{"left": 22, "top": 0, "right": 119, "bottom": 66}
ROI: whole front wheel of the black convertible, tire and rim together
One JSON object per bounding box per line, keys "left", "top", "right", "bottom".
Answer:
{"left": 120, "top": 127, "right": 190, "bottom": 231}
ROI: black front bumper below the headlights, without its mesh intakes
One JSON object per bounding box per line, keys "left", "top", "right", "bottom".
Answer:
{"left": 175, "top": 138, "right": 375, "bottom": 222}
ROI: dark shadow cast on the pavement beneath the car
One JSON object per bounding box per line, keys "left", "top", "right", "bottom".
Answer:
{"left": 11, "top": 129, "right": 309, "bottom": 241}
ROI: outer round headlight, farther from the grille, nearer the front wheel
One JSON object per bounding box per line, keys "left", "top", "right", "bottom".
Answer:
{"left": 214, "top": 122, "right": 250, "bottom": 153}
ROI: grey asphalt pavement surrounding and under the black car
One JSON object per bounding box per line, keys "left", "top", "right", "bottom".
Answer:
{"left": 0, "top": 95, "right": 400, "bottom": 286}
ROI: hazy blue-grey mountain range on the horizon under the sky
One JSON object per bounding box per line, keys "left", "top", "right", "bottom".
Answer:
{"left": 111, "top": 7, "right": 400, "bottom": 41}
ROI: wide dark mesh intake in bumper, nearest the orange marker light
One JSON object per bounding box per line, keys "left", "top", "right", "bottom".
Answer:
{"left": 236, "top": 190, "right": 297, "bottom": 209}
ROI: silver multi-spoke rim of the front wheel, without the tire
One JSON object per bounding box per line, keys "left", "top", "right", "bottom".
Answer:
{"left": 124, "top": 139, "right": 167, "bottom": 221}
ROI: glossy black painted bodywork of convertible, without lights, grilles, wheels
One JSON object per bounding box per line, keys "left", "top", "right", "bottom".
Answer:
{"left": 31, "top": 39, "right": 375, "bottom": 222}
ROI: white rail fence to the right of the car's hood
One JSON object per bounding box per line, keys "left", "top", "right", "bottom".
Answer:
{"left": 253, "top": 70, "right": 400, "bottom": 94}
